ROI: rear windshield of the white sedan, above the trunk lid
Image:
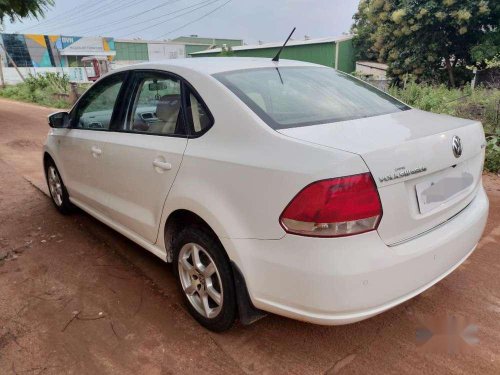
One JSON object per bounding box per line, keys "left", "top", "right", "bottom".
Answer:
{"left": 214, "top": 67, "right": 409, "bottom": 129}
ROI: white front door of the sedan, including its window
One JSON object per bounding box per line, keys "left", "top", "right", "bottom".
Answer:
{"left": 58, "top": 73, "right": 126, "bottom": 213}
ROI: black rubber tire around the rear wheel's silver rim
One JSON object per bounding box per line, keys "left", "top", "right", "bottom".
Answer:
{"left": 173, "top": 225, "right": 237, "bottom": 332}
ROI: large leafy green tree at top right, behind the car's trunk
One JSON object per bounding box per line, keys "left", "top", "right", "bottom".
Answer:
{"left": 352, "top": 0, "right": 500, "bottom": 86}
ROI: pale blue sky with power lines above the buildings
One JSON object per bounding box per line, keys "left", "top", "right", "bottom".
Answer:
{"left": 3, "top": 0, "right": 359, "bottom": 44}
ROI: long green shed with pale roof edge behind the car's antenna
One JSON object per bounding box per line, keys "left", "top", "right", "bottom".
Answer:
{"left": 186, "top": 35, "right": 356, "bottom": 73}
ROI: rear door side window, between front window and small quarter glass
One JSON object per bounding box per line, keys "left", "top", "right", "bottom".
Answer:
{"left": 125, "top": 72, "right": 186, "bottom": 135}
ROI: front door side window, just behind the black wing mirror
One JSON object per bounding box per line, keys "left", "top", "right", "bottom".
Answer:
{"left": 73, "top": 74, "right": 125, "bottom": 130}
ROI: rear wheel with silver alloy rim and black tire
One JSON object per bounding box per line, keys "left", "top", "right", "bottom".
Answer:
{"left": 174, "top": 226, "right": 236, "bottom": 332}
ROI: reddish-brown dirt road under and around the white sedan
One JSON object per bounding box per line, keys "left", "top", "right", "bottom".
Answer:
{"left": 0, "top": 100, "right": 500, "bottom": 374}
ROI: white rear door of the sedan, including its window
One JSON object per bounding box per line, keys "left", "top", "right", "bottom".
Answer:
{"left": 100, "top": 71, "right": 187, "bottom": 243}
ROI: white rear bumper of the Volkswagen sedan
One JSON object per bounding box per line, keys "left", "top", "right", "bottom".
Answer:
{"left": 225, "top": 187, "right": 488, "bottom": 325}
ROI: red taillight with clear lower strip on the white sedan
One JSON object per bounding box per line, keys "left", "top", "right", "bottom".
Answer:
{"left": 280, "top": 173, "right": 382, "bottom": 237}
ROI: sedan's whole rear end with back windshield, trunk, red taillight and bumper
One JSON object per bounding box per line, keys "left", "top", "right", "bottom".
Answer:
{"left": 214, "top": 63, "right": 488, "bottom": 324}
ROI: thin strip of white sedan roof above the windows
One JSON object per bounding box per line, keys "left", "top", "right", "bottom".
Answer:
{"left": 114, "top": 57, "right": 324, "bottom": 75}
